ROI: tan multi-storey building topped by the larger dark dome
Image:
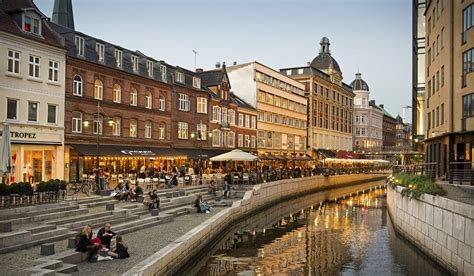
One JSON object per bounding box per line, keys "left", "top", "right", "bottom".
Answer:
{"left": 280, "top": 37, "right": 355, "bottom": 151}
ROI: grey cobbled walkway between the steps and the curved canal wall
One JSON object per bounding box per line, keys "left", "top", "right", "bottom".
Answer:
{"left": 74, "top": 207, "right": 224, "bottom": 275}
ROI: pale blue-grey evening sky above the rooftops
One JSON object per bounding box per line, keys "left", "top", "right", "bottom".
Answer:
{"left": 34, "top": 0, "right": 412, "bottom": 121}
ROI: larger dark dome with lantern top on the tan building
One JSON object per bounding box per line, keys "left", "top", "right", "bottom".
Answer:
{"left": 310, "top": 37, "right": 342, "bottom": 82}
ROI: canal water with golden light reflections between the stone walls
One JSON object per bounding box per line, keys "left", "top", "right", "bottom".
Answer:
{"left": 192, "top": 188, "right": 447, "bottom": 275}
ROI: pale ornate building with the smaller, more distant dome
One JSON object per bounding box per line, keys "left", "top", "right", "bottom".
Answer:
{"left": 351, "top": 73, "right": 383, "bottom": 151}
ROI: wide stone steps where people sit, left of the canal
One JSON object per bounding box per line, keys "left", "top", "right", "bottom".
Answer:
{"left": 0, "top": 186, "right": 243, "bottom": 275}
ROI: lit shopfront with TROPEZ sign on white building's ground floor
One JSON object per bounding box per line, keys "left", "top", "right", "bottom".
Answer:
{"left": 0, "top": 124, "right": 64, "bottom": 183}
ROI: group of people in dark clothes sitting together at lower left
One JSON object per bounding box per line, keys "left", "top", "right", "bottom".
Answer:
{"left": 76, "top": 223, "right": 130, "bottom": 262}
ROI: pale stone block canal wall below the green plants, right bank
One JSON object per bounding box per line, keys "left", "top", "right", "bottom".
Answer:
{"left": 387, "top": 186, "right": 474, "bottom": 275}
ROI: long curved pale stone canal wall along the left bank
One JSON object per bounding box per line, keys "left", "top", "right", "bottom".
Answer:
{"left": 125, "top": 174, "right": 386, "bottom": 275}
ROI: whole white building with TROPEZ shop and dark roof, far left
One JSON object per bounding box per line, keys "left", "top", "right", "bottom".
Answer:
{"left": 0, "top": 1, "right": 66, "bottom": 182}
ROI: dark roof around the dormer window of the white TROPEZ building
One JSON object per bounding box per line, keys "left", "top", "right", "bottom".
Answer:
{"left": 0, "top": 0, "right": 65, "bottom": 48}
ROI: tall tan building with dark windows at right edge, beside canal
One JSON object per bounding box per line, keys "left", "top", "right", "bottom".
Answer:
{"left": 424, "top": 0, "right": 474, "bottom": 177}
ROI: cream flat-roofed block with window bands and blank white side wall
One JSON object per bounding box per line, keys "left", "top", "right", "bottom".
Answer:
{"left": 227, "top": 62, "right": 307, "bottom": 157}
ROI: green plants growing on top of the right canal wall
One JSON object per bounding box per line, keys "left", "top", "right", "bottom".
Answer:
{"left": 393, "top": 173, "right": 446, "bottom": 198}
